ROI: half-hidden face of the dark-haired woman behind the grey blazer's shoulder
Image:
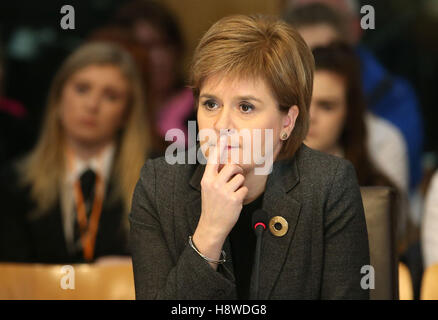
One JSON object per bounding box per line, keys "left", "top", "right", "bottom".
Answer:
{"left": 304, "top": 71, "right": 347, "bottom": 153}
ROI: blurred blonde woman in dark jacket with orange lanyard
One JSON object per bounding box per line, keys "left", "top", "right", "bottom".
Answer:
{"left": 0, "top": 43, "right": 149, "bottom": 263}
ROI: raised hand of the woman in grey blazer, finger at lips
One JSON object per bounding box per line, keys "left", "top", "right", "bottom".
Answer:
{"left": 193, "top": 136, "right": 248, "bottom": 266}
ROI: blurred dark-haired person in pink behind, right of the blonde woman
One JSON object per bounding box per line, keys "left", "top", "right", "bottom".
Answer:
{"left": 115, "top": 0, "right": 196, "bottom": 154}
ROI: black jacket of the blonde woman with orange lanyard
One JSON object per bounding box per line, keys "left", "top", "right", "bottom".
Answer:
{"left": 0, "top": 167, "right": 128, "bottom": 263}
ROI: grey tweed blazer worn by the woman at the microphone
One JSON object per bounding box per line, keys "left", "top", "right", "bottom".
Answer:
{"left": 130, "top": 144, "right": 369, "bottom": 300}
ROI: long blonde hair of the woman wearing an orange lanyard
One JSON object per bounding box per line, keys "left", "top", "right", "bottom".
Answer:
{"left": 18, "top": 42, "right": 150, "bottom": 214}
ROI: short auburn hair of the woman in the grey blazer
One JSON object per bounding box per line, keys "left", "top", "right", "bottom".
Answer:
{"left": 190, "top": 15, "right": 315, "bottom": 159}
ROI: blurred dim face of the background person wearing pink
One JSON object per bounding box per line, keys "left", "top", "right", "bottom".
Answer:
{"left": 134, "top": 21, "right": 176, "bottom": 93}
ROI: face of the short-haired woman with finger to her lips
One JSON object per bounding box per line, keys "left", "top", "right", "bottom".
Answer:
{"left": 198, "top": 75, "right": 298, "bottom": 170}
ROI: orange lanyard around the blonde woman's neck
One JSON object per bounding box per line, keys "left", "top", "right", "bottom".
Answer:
{"left": 74, "top": 175, "right": 104, "bottom": 261}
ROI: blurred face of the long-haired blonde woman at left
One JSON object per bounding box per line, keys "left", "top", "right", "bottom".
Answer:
{"left": 60, "top": 64, "right": 129, "bottom": 149}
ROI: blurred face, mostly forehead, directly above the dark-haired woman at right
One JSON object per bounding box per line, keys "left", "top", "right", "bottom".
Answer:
{"left": 298, "top": 24, "right": 339, "bottom": 49}
